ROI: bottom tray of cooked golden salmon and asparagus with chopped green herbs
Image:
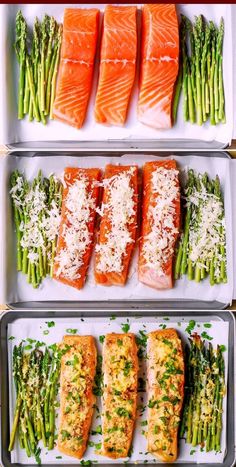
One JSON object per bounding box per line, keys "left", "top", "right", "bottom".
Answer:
{"left": 2, "top": 310, "right": 234, "bottom": 466}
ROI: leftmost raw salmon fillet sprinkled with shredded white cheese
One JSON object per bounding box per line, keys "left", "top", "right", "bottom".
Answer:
{"left": 53, "top": 168, "right": 100, "bottom": 289}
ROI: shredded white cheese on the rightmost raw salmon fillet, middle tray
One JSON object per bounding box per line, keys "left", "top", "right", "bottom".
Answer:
{"left": 143, "top": 167, "right": 179, "bottom": 277}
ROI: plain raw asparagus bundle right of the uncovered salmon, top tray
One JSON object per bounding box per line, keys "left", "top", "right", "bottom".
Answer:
{"left": 173, "top": 15, "right": 226, "bottom": 125}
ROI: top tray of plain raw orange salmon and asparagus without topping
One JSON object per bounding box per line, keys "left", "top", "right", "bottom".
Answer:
{"left": 0, "top": 4, "right": 233, "bottom": 148}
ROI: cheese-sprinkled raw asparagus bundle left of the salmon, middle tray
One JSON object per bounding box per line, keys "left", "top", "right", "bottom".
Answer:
{"left": 10, "top": 171, "right": 62, "bottom": 288}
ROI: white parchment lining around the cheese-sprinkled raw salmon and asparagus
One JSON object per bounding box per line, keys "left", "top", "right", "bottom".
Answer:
{"left": 0, "top": 154, "right": 233, "bottom": 303}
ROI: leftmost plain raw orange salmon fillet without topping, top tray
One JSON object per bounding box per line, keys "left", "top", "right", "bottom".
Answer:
{"left": 53, "top": 8, "right": 99, "bottom": 128}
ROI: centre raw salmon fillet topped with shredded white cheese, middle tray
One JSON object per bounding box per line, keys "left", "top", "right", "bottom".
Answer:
{"left": 95, "top": 165, "right": 138, "bottom": 285}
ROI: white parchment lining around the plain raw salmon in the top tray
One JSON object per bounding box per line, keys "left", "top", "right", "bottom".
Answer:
{"left": 0, "top": 4, "right": 233, "bottom": 148}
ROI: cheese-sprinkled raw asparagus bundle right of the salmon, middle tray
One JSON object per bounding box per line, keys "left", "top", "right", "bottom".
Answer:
{"left": 175, "top": 170, "right": 227, "bottom": 285}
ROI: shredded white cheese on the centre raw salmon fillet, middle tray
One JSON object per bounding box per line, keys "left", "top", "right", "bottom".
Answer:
{"left": 96, "top": 167, "right": 135, "bottom": 273}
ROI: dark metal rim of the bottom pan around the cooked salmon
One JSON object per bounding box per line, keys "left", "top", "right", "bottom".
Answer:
{"left": 0, "top": 308, "right": 236, "bottom": 467}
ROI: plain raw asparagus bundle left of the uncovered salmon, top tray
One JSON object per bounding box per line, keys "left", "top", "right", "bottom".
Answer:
{"left": 15, "top": 11, "right": 62, "bottom": 124}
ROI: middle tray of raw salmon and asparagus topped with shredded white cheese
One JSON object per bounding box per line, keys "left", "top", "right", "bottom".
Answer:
{"left": 0, "top": 153, "right": 234, "bottom": 306}
